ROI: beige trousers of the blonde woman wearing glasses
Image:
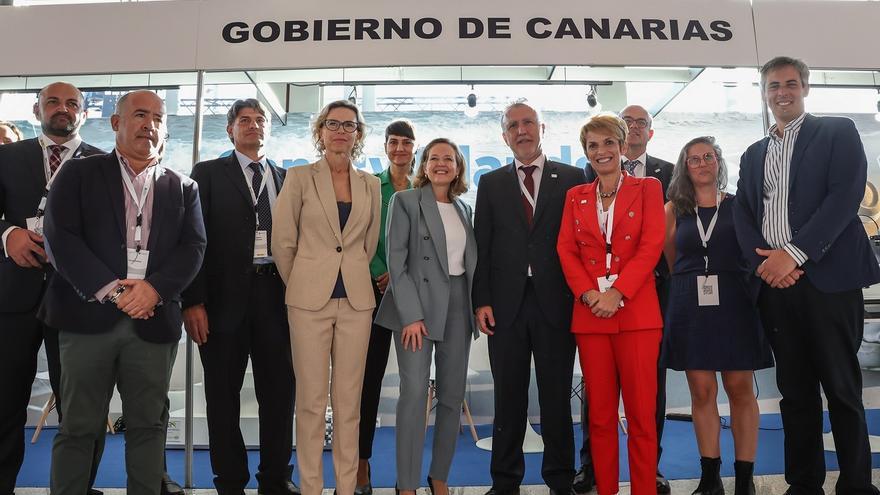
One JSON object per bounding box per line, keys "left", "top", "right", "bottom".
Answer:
{"left": 287, "top": 298, "right": 373, "bottom": 495}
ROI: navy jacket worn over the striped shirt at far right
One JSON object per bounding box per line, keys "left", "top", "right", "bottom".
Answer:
{"left": 734, "top": 114, "right": 880, "bottom": 292}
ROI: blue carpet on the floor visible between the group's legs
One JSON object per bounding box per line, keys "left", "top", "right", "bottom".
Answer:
{"left": 17, "top": 409, "right": 880, "bottom": 488}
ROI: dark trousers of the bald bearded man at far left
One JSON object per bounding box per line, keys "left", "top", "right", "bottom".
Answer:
{"left": 0, "top": 308, "right": 68, "bottom": 493}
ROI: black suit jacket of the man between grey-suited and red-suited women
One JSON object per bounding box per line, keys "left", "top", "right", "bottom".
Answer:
{"left": 473, "top": 160, "right": 584, "bottom": 332}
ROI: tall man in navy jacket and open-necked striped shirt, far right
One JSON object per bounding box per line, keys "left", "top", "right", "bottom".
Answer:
{"left": 734, "top": 57, "right": 880, "bottom": 495}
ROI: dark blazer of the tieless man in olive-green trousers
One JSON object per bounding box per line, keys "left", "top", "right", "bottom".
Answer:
{"left": 39, "top": 152, "right": 206, "bottom": 343}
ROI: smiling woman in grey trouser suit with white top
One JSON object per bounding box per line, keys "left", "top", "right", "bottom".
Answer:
{"left": 376, "top": 138, "right": 479, "bottom": 495}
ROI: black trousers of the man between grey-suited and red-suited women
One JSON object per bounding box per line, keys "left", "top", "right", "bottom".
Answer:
{"left": 489, "top": 282, "right": 575, "bottom": 493}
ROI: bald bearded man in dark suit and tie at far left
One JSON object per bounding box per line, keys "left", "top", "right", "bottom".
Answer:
{"left": 0, "top": 82, "right": 104, "bottom": 493}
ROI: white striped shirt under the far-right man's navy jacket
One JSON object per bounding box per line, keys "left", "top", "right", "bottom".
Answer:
{"left": 761, "top": 113, "right": 809, "bottom": 266}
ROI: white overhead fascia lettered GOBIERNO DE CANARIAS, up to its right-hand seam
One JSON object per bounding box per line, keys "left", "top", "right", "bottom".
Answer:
{"left": 0, "top": 0, "right": 757, "bottom": 76}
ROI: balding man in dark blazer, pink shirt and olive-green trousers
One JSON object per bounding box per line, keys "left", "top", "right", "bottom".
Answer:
{"left": 39, "top": 91, "right": 205, "bottom": 495}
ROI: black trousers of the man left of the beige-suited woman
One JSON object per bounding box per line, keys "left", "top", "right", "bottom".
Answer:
{"left": 199, "top": 271, "right": 296, "bottom": 494}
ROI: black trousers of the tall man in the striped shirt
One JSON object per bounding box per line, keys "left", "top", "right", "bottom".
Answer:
{"left": 758, "top": 277, "right": 876, "bottom": 495}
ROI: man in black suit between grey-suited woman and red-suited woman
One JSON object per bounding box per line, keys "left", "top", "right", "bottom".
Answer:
{"left": 473, "top": 102, "right": 584, "bottom": 495}
